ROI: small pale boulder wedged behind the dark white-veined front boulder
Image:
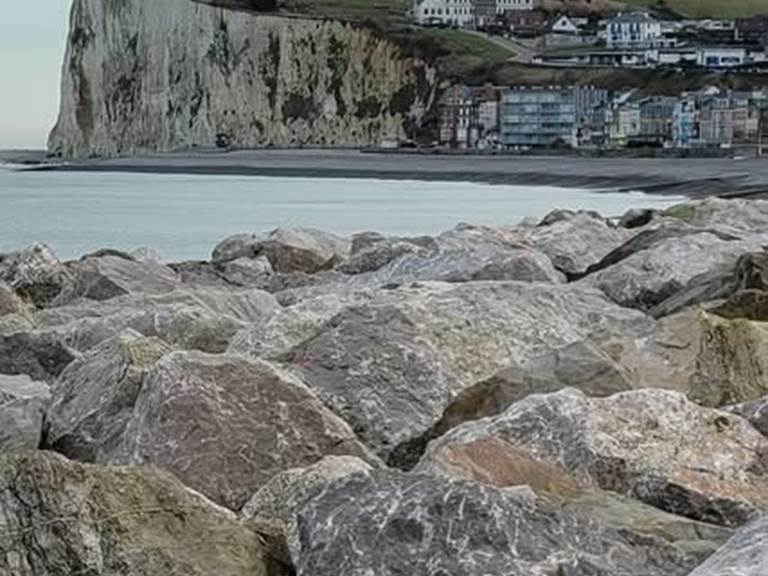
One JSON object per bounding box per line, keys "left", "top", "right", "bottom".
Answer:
{"left": 239, "top": 456, "right": 373, "bottom": 562}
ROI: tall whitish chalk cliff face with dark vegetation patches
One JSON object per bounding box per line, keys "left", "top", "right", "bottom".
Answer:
{"left": 49, "top": 0, "right": 435, "bottom": 157}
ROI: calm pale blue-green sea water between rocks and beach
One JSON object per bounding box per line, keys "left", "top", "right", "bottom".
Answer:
{"left": 0, "top": 168, "right": 679, "bottom": 260}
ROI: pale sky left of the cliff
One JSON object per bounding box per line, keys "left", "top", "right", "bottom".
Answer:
{"left": 0, "top": 0, "right": 71, "bottom": 148}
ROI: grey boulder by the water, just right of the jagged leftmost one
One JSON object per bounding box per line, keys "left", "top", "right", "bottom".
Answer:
{"left": 68, "top": 252, "right": 181, "bottom": 300}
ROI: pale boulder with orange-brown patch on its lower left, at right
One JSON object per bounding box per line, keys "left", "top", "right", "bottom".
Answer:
{"left": 419, "top": 389, "right": 768, "bottom": 526}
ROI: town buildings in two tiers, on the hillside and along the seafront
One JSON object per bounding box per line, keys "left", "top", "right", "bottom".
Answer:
{"left": 411, "top": 0, "right": 768, "bottom": 155}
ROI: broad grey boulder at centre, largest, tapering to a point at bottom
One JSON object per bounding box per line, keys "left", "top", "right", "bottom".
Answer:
{"left": 248, "top": 282, "right": 652, "bottom": 466}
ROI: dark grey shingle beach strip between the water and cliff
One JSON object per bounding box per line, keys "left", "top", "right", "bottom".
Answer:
{"left": 12, "top": 149, "right": 768, "bottom": 198}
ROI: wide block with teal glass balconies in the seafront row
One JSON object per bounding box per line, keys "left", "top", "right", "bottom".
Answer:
{"left": 500, "top": 86, "right": 608, "bottom": 147}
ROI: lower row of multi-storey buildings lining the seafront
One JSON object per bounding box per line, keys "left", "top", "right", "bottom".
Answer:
{"left": 438, "top": 85, "right": 768, "bottom": 149}
